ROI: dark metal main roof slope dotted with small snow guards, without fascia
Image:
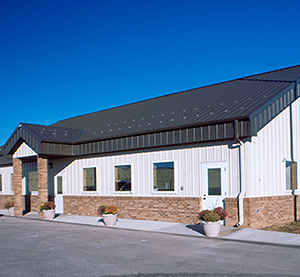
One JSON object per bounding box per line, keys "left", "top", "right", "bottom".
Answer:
{"left": 52, "top": 66, "right": 300, "bottom": 142}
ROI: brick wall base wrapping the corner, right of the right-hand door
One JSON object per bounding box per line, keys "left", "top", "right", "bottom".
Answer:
{"left": 225, "top": 195, "right": 300, "bottom": 228}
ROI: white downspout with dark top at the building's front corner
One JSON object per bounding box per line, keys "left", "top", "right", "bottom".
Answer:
{"left": 234, "top": 120, "right": 245, "bottom": 227}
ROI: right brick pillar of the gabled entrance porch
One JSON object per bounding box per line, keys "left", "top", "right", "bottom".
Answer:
{"left": 37, "top": 157, "right": 48, "bottom": 204}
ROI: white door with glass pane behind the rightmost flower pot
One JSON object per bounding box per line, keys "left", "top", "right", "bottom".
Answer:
{"left": 201, "top": 162, "right": 227, "bottom": 210}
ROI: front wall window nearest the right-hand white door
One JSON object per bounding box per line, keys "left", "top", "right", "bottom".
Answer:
{"left": 153, "top": 162, "right": 174, "bottom": 191}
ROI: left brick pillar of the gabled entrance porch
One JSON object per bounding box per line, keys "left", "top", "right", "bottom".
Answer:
{"left": 13, "top": 158, "right": 24, "bottom": 216}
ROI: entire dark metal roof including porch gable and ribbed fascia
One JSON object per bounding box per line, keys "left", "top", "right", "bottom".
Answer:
{"left": 0, "top": 65, "right": 300, "bottom": 165}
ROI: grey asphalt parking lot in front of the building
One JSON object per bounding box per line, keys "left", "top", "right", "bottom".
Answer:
{"left": 0, "top": 216, "right": 300, "bottom": 276}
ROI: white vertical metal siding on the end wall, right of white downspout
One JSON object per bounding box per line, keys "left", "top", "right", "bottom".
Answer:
{"left": 245, "top": 106, "right": 290, "bottom": 196}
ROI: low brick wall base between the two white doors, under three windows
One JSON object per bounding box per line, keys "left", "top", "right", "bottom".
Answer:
{"left": 64, "top": 196, "right": 202, "bottom": 223}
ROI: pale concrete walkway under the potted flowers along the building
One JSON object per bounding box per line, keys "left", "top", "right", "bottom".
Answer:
{"left": 0, "top": 210, "right": 300, "bottom": 248}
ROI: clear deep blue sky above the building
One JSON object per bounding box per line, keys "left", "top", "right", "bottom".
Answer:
{"left": 0, "top": 0, "right": 300, "bottom": 145}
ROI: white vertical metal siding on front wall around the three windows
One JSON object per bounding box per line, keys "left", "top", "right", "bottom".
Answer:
{"left": 51, "top": 142, "right": 239, "bottom": 197}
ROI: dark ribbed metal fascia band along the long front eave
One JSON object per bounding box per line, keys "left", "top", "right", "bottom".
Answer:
{"left": 40, "top": 118, "right": 250, "bottom": 157}
